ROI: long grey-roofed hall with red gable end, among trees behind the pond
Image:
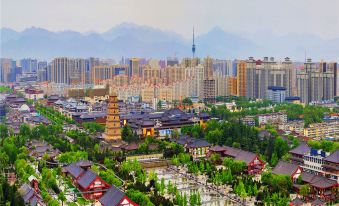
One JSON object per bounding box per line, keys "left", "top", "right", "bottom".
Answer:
{"left": 209, "top": 146, "right": 265, "bottom": 174}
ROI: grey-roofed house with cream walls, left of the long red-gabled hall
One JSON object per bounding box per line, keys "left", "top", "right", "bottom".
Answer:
{"left": 171, "top": 135, "right": 211, "bottom": 158}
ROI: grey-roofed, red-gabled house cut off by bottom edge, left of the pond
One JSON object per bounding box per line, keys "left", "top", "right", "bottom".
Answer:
{"left": 95, "top": 185, "right": 137, "bottom": 206}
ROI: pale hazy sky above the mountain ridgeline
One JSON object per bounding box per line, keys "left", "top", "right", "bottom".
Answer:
{"left": 0, "top": 0, "right": 339, "bottom": 39}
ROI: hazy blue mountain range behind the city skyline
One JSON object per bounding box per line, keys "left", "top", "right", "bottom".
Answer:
{"left": 0, "top": 23, "right": 339, "bottom": 61}
